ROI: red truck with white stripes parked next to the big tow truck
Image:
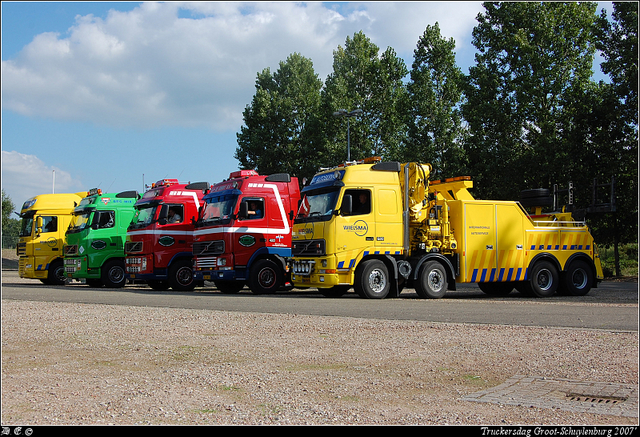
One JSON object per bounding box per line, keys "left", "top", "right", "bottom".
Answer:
{"left": 193, "top": 170, "right": 300, "bottom": 294}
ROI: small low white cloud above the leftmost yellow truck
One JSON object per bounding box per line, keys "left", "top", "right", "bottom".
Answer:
{"left": 2, "top": 150, "right": 86, "bottom": 206}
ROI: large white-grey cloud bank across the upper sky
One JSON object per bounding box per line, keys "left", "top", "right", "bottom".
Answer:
{"left": 2, "top": 2, "right": 481, "bottom": 130}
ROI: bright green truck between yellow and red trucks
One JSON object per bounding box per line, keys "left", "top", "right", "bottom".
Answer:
{"left": 64, "top": 188, "right": 140, "bottom": 288}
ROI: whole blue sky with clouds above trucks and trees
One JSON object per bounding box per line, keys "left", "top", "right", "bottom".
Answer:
{"left": 2, "top": 2, "right": 611, "bottom": 209}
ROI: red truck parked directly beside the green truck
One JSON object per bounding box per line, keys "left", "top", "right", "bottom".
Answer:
{"left": 125, "top": 179, "right": 209, "bottom": 291}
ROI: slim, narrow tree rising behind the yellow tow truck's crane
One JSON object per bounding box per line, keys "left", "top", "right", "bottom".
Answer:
{"left": 402, "top": 23, "right": 463, "bottom": 179}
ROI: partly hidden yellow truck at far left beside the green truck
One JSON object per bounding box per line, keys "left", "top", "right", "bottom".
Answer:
{"left": 16, "top": 192, "right": 86, "bottom": 285}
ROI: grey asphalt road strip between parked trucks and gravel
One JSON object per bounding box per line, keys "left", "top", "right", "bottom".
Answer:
{"left": 2, "top": 270, "right": 638, "bottom": 331}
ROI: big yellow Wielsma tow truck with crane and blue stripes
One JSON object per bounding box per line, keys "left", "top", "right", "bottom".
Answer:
{"left": 291, "top": 158, "right": 603, "bottom": 299}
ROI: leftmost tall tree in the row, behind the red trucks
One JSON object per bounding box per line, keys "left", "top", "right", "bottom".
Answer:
{"left": 234, "top": 53, "right": 323, "bottom": 182}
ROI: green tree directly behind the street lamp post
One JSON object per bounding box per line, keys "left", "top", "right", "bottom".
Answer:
{"left": 322, "top": 31, "right": 407, "bottom": 166}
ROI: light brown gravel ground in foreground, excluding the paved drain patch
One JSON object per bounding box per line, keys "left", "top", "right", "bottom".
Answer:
{"left": 1, "top": 250, "right": 638, "bottom": 426}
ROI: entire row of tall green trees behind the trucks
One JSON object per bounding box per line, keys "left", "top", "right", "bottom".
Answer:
{"left": 235, "top": 2, "right": 638, "bottom": 244}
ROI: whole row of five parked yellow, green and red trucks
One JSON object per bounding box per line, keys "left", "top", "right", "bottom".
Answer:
{"left": 17, "top": 158, "right": 603, "bottom": 298}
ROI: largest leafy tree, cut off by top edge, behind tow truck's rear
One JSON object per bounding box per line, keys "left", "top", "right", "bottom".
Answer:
{"left": 462, "top": 2, "right": 596, "bottom": 199}
